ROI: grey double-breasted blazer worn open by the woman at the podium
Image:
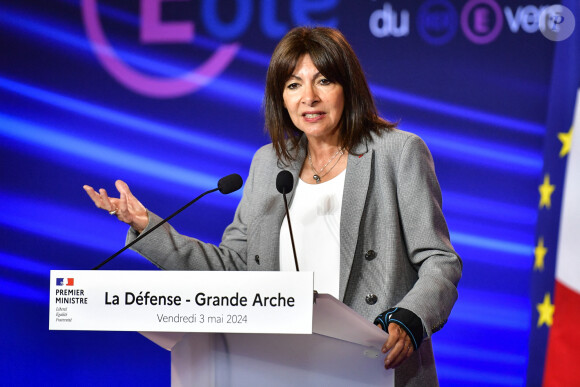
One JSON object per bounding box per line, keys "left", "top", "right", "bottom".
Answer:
{"left": 128, "top": 130, "right": 462, "bottom": 386}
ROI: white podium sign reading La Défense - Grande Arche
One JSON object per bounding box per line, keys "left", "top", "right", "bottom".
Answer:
{"left": 49, "top": 270, "right": 314, "bottom": 334}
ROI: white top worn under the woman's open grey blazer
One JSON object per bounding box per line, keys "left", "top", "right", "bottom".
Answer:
{"left": 280, "top": 169, "right": 346, "bottom": 298}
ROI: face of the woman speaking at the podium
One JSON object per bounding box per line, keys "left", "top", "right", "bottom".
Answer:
{"left": 282, "top": 54, "right": 344, "bottom": 141}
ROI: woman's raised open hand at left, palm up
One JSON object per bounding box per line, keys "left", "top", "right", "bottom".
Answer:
{"left": 83, "top": 180, "right": 149, "bottom": 232}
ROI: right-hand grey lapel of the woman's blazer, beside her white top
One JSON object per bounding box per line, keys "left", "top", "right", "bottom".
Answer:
{"left": 339, "top": 143, "right": 373, "bottom": 300}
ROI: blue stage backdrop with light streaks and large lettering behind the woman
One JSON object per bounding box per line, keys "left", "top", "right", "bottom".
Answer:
{"left": 0, "top": 0, "right": 556, "bottom": 386}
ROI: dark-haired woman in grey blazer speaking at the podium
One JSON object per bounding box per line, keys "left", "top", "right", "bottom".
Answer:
{"left": 84, "top": 27, "right": 462, "bottom": 386}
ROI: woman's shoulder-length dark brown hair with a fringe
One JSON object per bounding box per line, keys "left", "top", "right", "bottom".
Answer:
{"left": 264, "top": 27, "right": 395, "bottom": 160}
